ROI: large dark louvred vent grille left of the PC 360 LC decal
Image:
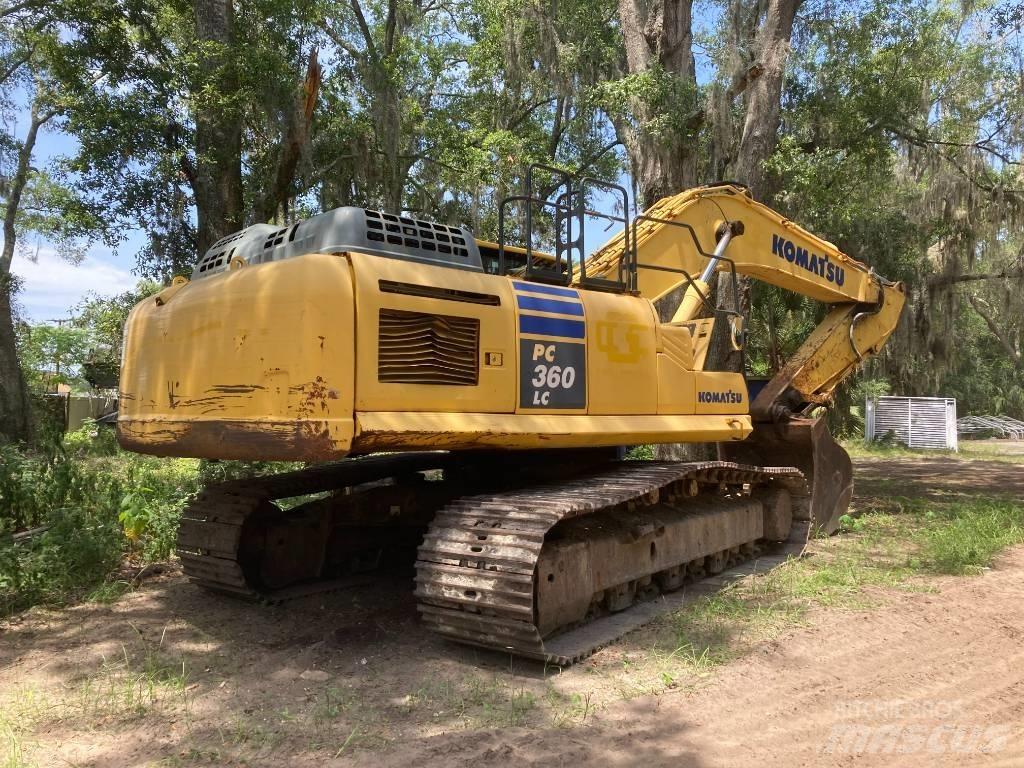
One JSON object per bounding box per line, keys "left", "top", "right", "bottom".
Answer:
{"left": 377, "top": 309, "right": 480, "bottom": 386}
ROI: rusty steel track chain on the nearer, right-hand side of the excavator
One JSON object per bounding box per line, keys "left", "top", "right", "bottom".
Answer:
{"left": 416, "top": 462, "right": 809, "bottom": 666}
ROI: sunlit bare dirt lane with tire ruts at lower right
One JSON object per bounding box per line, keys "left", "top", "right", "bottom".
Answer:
{"left": 333, "top": 549, "right": 1024, "bottom": 768}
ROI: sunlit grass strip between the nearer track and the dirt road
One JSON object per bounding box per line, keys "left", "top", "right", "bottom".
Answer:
{"left": 621, "top": 497, "right": 1024, "bottom": 697}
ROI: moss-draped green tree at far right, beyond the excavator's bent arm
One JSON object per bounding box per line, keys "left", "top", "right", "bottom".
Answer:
{"left": 771, "top": 2, "right": 1024, "bottom": 403}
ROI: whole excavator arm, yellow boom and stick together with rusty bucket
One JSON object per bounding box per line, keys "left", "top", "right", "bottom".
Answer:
{"left": 577, "top": 184, "right": 905, "bottom": 532}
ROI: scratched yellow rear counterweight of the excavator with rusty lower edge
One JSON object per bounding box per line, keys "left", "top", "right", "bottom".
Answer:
{"left": 118, "top": 254, "right": 354, "bottom": 459}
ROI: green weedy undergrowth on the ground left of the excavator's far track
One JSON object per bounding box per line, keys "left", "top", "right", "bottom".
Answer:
{"left": 0, "top": 442, "right": 198, "bottom": 614}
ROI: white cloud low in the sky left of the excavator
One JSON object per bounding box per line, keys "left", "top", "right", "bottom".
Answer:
{"left": 11, "top": 249, "right": 138, "bottom": 323}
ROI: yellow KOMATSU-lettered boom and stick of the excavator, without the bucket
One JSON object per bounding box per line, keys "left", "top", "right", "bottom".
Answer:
{"left": 586, "top": 184, "right": 905, "bottom": 418}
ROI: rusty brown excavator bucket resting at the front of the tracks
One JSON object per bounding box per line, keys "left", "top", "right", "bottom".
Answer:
{"left": 719, "top": 418, "right": 853, "bottom": 535}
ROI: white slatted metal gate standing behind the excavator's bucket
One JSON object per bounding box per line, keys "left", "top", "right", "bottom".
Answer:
{"left": 864, "top": 396, "right": 956, "bottom": 451}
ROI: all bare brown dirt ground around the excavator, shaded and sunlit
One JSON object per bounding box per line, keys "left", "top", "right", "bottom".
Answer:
{"left": 0, "top": 458, "right": 1024, "bottom": 768}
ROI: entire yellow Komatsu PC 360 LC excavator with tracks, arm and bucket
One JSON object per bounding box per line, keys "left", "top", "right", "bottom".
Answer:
{"left": 118, "top": 167, "right": 904, "bottom": 664}
